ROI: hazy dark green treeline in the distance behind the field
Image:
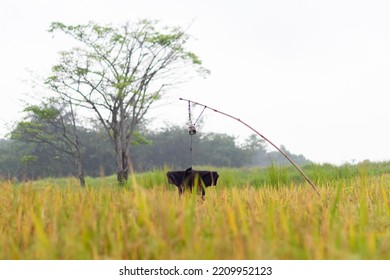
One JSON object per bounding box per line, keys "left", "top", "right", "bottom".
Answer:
{"left": 0, "top": 126, "right": 310, "bottom": 179}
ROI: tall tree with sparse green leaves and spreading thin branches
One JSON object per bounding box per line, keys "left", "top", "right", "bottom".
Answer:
{"left": 46, "top": 20, "right": 208, "bottom": 182}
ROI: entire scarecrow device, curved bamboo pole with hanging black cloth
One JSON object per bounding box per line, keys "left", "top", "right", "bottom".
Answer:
{"left": 167, "top": 98, "right": 321, "bottom": 197}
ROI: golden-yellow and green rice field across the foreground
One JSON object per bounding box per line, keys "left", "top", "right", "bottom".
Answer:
{"left": 0, "top": 163, "right": 390, "bottom": 260}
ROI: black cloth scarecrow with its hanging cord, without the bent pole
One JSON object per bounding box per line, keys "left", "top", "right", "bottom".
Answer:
{"left": 167, "top": 101, "right": 219, "bottom": 198}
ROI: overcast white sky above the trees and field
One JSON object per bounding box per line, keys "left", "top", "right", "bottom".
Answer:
{"left": 0, "top": 0, "right": 390, "bottom": 164}
